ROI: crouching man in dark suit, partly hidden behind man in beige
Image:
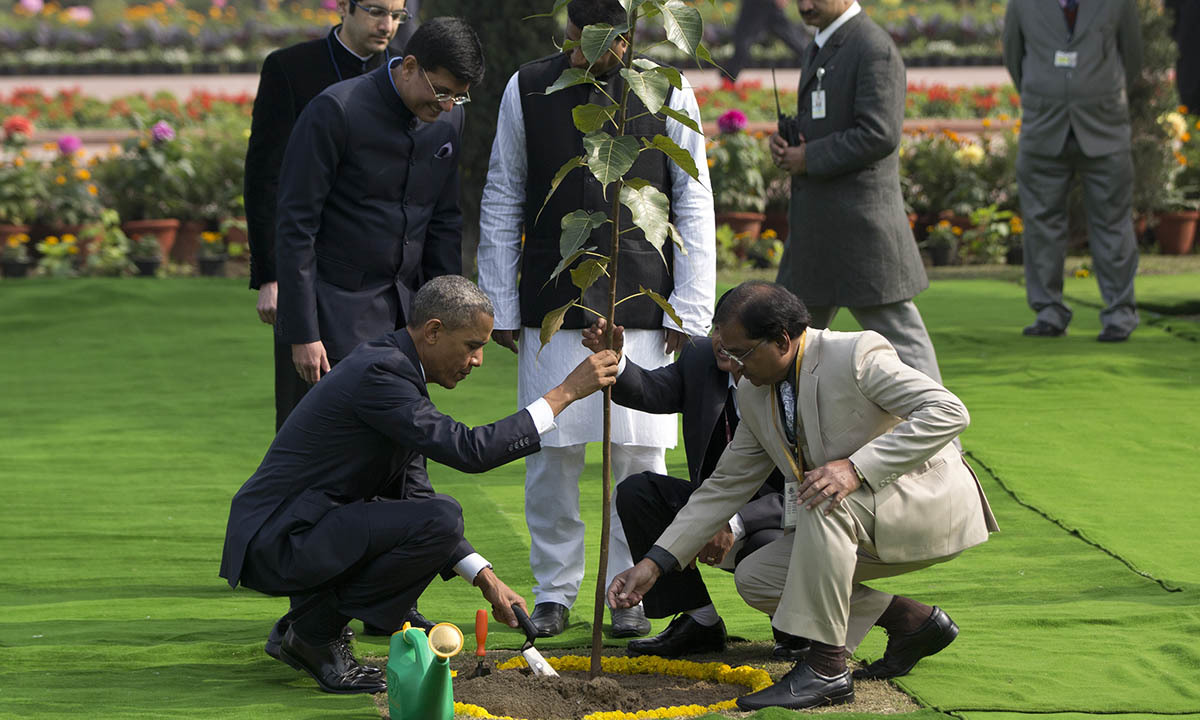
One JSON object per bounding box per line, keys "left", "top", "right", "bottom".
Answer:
{"left": 583, "top": 316, "right": 808, "bottom": 660}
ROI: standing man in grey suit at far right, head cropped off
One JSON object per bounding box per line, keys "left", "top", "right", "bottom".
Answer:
{"left": 1004, "top": 0, "right": 1142, "bottom": 342}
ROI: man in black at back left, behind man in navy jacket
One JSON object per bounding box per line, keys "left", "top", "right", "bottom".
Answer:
{"left": 244, "top": 0, "right": 417, "bottom": 431}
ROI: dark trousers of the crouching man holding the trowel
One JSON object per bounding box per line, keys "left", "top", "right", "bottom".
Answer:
{"left": 241, "top": 494, "right": 463, "bottom": 628}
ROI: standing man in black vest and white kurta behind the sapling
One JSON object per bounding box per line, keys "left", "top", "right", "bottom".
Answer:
{"left": 479, "top": 0, "right": 715, "bottom": 637}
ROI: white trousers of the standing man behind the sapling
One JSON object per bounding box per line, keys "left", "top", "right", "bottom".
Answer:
{"left": 526, "top": 444, "right": 667, "bottom": 607}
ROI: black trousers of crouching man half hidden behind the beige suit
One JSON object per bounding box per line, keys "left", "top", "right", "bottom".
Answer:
{"left": 616, "top": 473, "right": 784, "bottom": 618}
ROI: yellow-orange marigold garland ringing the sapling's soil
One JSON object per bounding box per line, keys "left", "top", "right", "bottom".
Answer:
{"left": 454, "top": 655, "right": 772, "bottom": 720}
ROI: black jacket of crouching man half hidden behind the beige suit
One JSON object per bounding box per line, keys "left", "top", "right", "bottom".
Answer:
{"left": 612, "top": 337, "right": 784, "bottom": 535}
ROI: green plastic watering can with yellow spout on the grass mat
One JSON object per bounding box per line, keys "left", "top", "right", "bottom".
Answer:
{"left": 388, "top": 623, "right": 462, "bottom": 720}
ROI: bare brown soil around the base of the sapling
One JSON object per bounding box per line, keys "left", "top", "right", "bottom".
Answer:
{"left": 365, "top": 642, "right": 919, "bottom": 720}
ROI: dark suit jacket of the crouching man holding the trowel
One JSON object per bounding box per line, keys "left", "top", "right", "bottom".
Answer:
{"left": 221, "top": 330, "right": 541, "bottom": 592}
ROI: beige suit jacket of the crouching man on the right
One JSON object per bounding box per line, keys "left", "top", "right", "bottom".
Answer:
{"left": 656, "top": 328, "right": 998, "bottom": 566}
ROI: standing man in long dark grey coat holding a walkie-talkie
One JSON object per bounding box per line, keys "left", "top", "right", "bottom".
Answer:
{"left": 770, "top": 0, "right": 942, "bottom": 382}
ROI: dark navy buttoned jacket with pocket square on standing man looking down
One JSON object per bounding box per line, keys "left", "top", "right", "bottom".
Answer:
{"left": 276, "top": 58, "right": 462, "bottom": 361}
